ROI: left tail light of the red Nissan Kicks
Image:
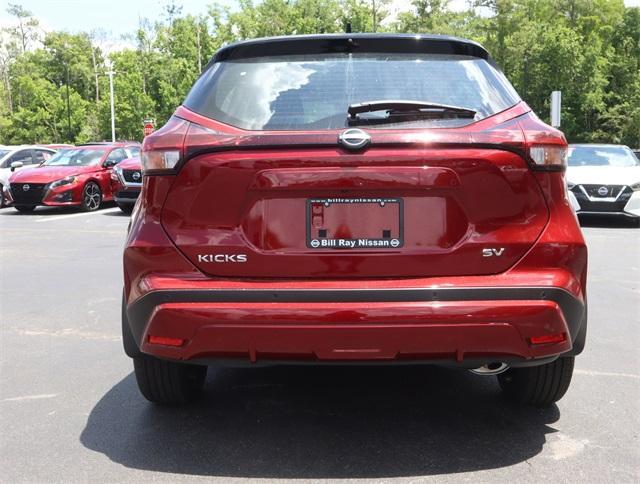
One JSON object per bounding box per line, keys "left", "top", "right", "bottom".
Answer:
{"left": 140, "top": 116, "right": 190, "bottom": 175}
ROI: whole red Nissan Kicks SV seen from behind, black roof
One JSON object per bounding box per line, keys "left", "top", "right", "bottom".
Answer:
{"left": 122, "top": 34, "right": 587, "bottom": 406}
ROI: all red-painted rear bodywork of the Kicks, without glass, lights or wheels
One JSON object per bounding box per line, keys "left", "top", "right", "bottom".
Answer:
{"left": 124, "top": 103, "right": 587, "bottom": 363}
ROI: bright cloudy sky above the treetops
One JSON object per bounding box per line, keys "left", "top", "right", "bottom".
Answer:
{"left": 0, "top": 0, "right": 640, "bottom": 40}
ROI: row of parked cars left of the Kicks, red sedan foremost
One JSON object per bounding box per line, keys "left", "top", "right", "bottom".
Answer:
{"left": 0, "top": 141, "right": 142, "bottom": 213}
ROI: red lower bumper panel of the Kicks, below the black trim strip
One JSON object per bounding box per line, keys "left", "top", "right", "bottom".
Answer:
{"left": 142, "top": 301, "right": 571, "bottom": 361}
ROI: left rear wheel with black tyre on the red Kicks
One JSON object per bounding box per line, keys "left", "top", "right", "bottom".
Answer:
{"left": 133, "top": 355, "right": 207, "bottom": 405}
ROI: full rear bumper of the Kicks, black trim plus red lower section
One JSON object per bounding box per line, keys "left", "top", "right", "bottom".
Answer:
{"left": 126, "top": 287, "right": 585, "bottom": 367}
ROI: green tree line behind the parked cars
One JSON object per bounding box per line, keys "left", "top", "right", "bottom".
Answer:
{"left": 0, "top": 0, "right": 640, "bottom": 147}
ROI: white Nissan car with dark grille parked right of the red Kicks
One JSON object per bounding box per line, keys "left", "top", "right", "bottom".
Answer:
{"left": 567, "top": 144, "right": 640, "bottom": 221}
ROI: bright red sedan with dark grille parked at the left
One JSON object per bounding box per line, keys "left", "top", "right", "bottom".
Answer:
{"left": 9, "top": 142, "right": 140, "bottom": 212}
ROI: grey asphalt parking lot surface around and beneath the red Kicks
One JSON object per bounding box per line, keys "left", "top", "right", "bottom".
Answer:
{"left": 0, "top": 202, "right": 640, "bottom": 483}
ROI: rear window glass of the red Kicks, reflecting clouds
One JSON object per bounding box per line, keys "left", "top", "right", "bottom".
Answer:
{"left": 184, "top": 54, "right": 520, "bottom": 130}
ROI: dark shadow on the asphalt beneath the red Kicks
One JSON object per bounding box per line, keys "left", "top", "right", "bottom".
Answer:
{"left": 80, "top": 366, "right": 560, "bottom": 479}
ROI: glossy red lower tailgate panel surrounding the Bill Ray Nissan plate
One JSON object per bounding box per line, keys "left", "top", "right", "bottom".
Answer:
{"left": 162, "top": 148, "right": 548, "bottom": 277}
